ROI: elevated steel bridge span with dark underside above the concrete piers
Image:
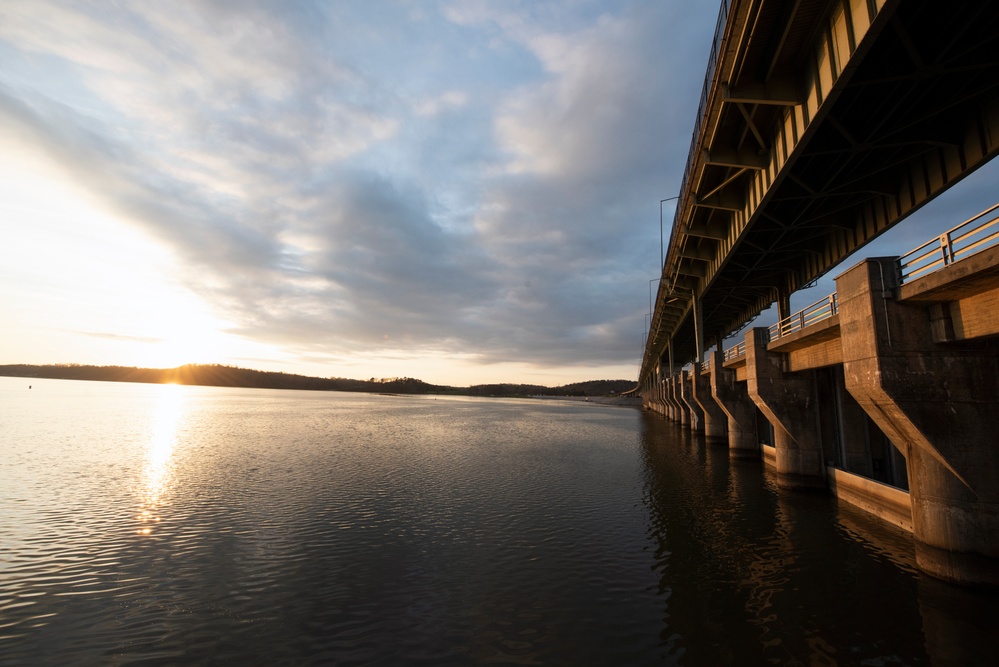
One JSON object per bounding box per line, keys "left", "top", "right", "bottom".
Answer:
{"left": 639, "top": 0, "right": 999, "bottom": 385}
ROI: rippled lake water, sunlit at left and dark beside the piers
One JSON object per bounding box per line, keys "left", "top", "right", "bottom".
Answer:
{"left": 0, "top": 378, "right": 999, "bottom": 666}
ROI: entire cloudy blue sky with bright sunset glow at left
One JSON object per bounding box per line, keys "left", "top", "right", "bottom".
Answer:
{"left": 0, "top": 0, "right": 995, "bottom": 386}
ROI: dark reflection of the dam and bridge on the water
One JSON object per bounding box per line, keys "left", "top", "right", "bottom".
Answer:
{"left": 643, "top": 414, "right": 999, "bottom": 665}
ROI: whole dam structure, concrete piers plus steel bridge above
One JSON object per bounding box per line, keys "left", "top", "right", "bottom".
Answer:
{"left": 635, "top": 0, "right": 999, "bottom": 586}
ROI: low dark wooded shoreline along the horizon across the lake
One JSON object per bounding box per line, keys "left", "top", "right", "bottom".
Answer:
{"left": 0, "top": 364, "right": 635, "bottom": 397}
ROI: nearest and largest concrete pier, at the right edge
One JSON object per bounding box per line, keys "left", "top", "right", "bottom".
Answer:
{"left": 836, "top": 258, "right": 999, "bottom": 586}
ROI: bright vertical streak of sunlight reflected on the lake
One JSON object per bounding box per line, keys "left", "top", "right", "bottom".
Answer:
{"left": 135, "top": 384, "right": 184, "bottom": 535}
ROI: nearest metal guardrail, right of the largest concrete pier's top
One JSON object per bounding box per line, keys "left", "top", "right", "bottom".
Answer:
{"left": 898, "top": 198, "right": 999, "bottom": 285}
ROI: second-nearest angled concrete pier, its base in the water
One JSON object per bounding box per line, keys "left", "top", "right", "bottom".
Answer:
{"left": 746, "top": 327, "right": 826, "bottom": 489}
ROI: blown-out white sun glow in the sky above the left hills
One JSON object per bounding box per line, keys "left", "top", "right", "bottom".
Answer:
{"left": 0, "top": 139, "right": 250, "bottom": 367}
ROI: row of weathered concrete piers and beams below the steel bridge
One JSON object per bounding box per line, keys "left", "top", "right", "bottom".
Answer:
{"left": 647, "top": 247, "right": 999, "bottom": 587}
